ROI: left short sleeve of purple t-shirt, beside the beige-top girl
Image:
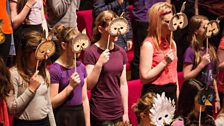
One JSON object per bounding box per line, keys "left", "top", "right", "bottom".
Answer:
{"left": 49, "top": 64, "right": 61, "bottom": 84}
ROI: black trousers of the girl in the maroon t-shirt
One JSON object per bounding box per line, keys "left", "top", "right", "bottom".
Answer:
{"left": 90, "top": 114, "right": 122, "bottom": 126}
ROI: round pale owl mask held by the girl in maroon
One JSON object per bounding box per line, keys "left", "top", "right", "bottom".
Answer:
{"left": 108, "top": 17, "right": 129, "bottom": 36}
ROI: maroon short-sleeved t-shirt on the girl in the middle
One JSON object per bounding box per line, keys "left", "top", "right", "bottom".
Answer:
{"left": 83, "top": 44, "right": 127, "bottom": 120}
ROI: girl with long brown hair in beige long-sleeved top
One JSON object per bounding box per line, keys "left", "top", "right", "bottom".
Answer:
{"left": 6, "top": 31, "right": 56, "bottom": 126}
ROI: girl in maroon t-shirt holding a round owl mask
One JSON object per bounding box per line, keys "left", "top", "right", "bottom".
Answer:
{"left": 83, "top": 10, "right": 129, "bottom": 126}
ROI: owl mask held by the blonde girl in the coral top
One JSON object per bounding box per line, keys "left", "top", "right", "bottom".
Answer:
{"left": 169, "top": 2, "right": 188, "bottom": 31}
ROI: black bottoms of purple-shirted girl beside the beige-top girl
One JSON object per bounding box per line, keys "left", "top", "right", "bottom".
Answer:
{"left": 54, "top": 104, "right": 85, "bottom": 126}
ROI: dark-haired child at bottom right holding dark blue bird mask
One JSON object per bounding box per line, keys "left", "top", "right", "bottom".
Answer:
{"left": 175, "top": 79, "right": 214, "bottom": 126}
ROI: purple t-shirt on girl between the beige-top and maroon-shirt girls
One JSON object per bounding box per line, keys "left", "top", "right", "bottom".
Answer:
{"left": 49, "top": 61, "right": 87, "bottom": 105}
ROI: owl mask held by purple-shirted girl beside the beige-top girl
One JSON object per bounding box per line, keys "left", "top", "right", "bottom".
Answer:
{"left": 72, "top": 34, "right": 90, "bottom": 53}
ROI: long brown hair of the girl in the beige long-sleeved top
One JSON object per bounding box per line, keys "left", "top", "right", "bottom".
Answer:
{"left": 16, "top": 31, "right": 49, "bottom": 86}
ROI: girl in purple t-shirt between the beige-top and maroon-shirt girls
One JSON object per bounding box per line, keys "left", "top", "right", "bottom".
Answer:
{"left": 49, "top": 25, "right": 90, "bottom": 126}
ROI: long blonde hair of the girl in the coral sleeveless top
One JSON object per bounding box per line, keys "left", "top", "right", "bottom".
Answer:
{"left": 148, "top": 2, "right": 174, "bottom": 49}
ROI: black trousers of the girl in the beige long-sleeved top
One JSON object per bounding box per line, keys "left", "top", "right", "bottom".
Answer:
{"left": 12, "top": 117, "right": 50, "bottom": 126}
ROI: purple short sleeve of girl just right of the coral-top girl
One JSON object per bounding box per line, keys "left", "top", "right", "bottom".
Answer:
{"left": 184, "top": 47, "right": 195, "bottom": 64}
